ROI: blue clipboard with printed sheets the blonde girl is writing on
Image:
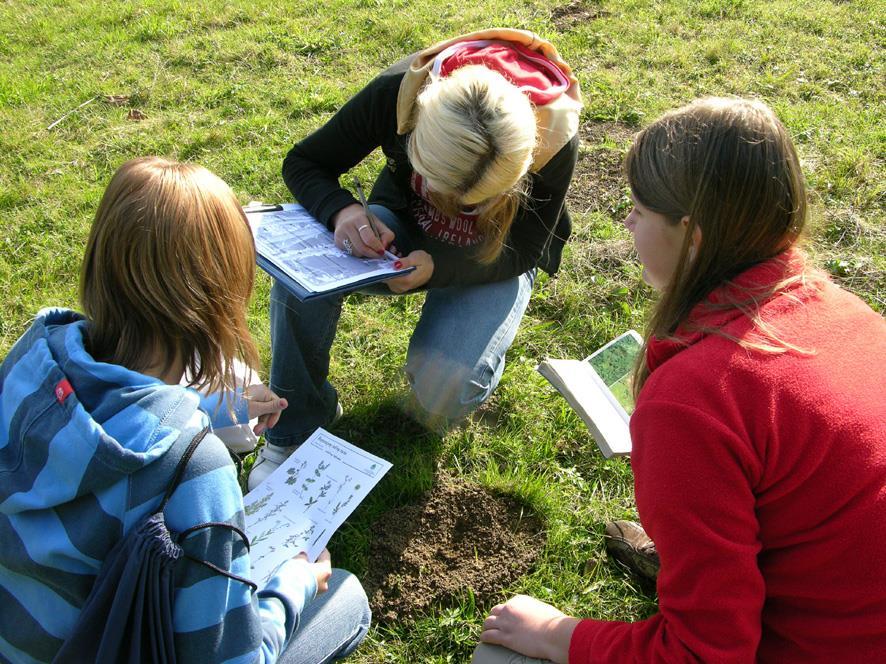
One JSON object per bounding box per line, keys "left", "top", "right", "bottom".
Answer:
{"left": 243, "top": 203, "right": 415, "bottom": 300}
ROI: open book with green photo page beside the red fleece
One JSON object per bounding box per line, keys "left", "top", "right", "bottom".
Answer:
{"left": 537, "top": 330, "right": 643, "bottom": 459}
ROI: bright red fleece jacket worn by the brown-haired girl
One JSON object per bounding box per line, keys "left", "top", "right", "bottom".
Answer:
{"left": 569, "top": 252, "right": 886, "bottom": 664}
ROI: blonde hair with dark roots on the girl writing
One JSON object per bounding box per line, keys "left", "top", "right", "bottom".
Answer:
{"left": 407, "top": 65, "right": 537, "bottom": 263}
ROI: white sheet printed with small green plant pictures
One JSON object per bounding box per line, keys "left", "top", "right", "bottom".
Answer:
{"left": 243, "top": 429, "right": 391, "bottom": 586}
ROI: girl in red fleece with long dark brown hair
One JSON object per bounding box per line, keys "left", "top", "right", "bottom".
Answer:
{"left": 481, "top": 99, "right": 886, "bottom": 663}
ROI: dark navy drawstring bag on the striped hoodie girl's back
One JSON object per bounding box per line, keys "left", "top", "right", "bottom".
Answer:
{"left": 53, "top": 427, "right": 258, "bottom": 664}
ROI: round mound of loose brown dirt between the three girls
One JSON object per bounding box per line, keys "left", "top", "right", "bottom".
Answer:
{"left": 363, "top": 478, "right": 544, "bottom": 622}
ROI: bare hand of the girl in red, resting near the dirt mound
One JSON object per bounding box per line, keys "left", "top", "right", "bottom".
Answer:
{"left": 480, "top": 595, "right": 578, "bottom": 664}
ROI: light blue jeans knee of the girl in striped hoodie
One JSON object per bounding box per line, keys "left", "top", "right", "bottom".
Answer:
{"left": 277, "top": 569, "right": 372, "bottom": 664}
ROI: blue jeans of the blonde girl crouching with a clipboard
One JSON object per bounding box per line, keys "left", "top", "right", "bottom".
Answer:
{"left": 266, "top": 205, "right": 535, "bottom": 447}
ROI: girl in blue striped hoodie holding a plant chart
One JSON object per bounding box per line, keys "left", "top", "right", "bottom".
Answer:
{"left": 0, "top": 157, "right": 369, "bottom": 664}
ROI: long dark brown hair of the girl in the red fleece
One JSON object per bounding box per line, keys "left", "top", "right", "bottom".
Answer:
{"left": 625, "top": 97, "right": 806, "bottom": 396}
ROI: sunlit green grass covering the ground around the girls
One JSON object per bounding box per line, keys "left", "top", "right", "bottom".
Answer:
{"left": 0, "top": 0, "right": 886, "bottom": 662}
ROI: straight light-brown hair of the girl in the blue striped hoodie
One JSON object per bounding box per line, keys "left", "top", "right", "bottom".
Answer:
{"left": 80, "top": 157, "right": 258, "bottom": 391}
